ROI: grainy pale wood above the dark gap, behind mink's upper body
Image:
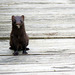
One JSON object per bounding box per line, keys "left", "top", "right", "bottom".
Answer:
{"left": 0, "top": 0, "right": 75, "bottom": 38}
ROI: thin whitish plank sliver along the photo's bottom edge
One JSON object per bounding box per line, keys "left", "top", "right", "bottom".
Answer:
{"left": 0, "top": 72, "right": 75, "bottom": 75}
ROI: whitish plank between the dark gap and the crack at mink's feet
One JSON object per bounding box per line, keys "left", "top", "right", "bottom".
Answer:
{"left": 0, "top": 39, "right": 75, "bottom": 56}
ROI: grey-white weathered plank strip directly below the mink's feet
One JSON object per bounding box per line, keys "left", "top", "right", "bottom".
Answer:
{"left": 0, "top": 53, "right": 75, "bottom": 64}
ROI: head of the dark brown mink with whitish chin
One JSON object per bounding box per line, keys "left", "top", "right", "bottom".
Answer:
{"left": 12, "top": 15, "right": 24, "bottom": 29}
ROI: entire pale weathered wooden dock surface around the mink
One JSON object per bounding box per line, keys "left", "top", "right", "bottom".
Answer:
{"left": 0, "top": 0, "right": 75, "bottom": 75}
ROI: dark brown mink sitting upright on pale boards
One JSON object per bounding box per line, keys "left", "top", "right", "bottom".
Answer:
{"left": 10, "top": 15, "right": 29, "bottom": 55}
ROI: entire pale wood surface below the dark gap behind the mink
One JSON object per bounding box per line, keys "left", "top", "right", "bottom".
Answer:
{"left": 0, "top": 39, "right": 75, "bottom": 75}
